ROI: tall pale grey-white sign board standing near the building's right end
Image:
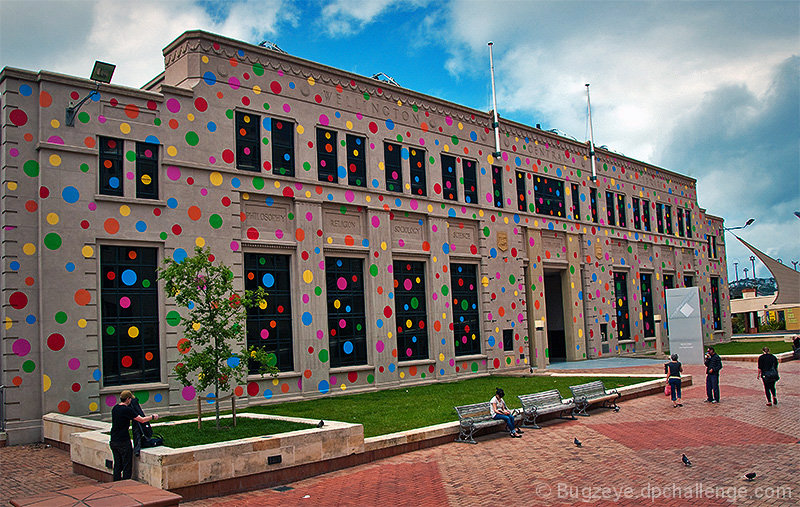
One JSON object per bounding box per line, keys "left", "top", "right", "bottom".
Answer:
{"left": 666, "top": 287, "right": 703, "bottom": 364}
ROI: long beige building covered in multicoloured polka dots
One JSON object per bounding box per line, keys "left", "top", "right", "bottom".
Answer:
{"left": 0, "top": 31, "right": 731, "bottom": 443}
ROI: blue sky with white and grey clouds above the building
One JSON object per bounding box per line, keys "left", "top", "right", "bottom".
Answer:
{"left": 0, "top": 0, "right": 800, "bottom": 281}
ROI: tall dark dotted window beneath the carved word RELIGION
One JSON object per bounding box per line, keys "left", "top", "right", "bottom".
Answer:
{"left": 325, "top": 257, "right": 367, "bottom": 368}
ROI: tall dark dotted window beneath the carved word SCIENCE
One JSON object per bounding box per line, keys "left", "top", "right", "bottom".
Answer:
{"left": 450, "top": 264, "right": 481, "bottom": 356}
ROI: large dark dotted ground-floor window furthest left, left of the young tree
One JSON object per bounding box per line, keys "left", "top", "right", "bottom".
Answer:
{"left": 100, "top": 245, "right": 161, "bottom": 386}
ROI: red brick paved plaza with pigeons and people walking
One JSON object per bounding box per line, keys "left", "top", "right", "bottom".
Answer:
{"left": 0, "top": 361, "right": 800, "bottom": 507}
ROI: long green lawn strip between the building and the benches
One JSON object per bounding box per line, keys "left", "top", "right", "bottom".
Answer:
{"left": 247, "top": 376, "right": 655, "bottom": 437}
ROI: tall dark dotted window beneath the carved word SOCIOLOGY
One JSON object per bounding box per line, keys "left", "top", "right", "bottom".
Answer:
{"left": 394, "top": 261, "right": 428, "bottom": 361}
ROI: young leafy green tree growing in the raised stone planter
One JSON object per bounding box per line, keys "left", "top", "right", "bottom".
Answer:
{"left": 158, "top": 247, "right": 278, "bottom": 429}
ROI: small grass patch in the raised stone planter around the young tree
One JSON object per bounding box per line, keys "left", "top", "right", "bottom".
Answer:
{"left": 153, "top": 416, "right": 314, "bottom": 449}
